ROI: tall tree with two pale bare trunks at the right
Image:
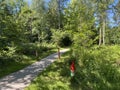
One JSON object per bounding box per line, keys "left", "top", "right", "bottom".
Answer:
{"left": 93, "top": 0, "right": 113, "bottom": 45}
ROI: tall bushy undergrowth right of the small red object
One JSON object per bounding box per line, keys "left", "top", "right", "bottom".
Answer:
{"left": 69, "top": 46, "right": 120, "bottom": 90}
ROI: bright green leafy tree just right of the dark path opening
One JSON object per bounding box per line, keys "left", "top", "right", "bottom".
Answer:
{"left": 65, "top": 0, "right": 96, "bottom": 47}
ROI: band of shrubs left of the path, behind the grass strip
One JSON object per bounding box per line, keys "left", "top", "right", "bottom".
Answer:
{"left": 0, "top": 43, "right": 51, "bottom": 67}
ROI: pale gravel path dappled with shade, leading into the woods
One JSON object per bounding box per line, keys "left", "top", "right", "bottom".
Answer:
{"left": 0, "top": 49, "right": 68, "bottom": 90}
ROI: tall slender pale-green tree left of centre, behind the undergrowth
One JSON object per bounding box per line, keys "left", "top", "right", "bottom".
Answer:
{"left": 32, "top": 0, "right": 49, "bottom": 42}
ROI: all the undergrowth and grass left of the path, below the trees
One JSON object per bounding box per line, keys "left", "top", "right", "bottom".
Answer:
{"left": 0, "top": 43, "right": 56, "bottom": 77}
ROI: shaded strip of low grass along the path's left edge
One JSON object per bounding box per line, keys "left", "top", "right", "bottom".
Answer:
{"left": 0, "top": 48, "right": 56, "bottom": 78}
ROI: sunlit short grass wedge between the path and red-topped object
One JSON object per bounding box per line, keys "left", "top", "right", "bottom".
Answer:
{"left": 25, "top": 52, "right": 70, "bottom": 90}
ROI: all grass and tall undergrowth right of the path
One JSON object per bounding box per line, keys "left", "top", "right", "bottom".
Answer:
{"left": 25, "top": 46, "right": 120, "bottom": 90}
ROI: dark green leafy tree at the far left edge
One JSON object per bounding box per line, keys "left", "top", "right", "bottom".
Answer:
{"left": 0, "top": 1, "right": 24, "bottom": 47}
